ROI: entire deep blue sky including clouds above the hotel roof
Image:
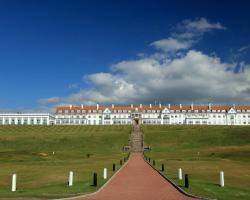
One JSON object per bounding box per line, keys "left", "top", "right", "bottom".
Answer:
{"left": 0, "top": 0, "right": 250, "bottom": 110}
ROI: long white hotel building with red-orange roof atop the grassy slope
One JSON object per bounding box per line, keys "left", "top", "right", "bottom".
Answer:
{"left": 0, "top": 104, "right": 250, "bottom": 125}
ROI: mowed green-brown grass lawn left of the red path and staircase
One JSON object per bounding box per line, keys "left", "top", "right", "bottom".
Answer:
{"left": 0, "top": 126, "right": 131, "bottom": 199}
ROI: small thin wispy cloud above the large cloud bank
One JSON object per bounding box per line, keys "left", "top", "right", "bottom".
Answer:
{"left": 151, "top": 18, "right": 226, "bottom": 52}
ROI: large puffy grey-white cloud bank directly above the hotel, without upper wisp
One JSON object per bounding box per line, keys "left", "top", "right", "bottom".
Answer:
{"left": 40, "top": 50, "right": 250, "bottom": 105}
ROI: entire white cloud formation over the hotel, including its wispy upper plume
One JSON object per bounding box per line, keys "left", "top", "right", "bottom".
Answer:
{"left": 40, "top": 18, "right": 250, "bottom": 105}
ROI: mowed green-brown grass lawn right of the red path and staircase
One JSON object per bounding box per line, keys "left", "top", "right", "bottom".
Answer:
{"left": 142, "top": 125, "right": 250, "bottom": 200}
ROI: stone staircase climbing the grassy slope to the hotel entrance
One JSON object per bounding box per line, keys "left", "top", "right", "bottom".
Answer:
{"left": 130, "top": 124, "right": 143, "bottom": 152}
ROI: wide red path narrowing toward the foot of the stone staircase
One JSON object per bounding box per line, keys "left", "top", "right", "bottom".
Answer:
{"left": 73, "top": 153, "right": 196, "bottom": 200}
